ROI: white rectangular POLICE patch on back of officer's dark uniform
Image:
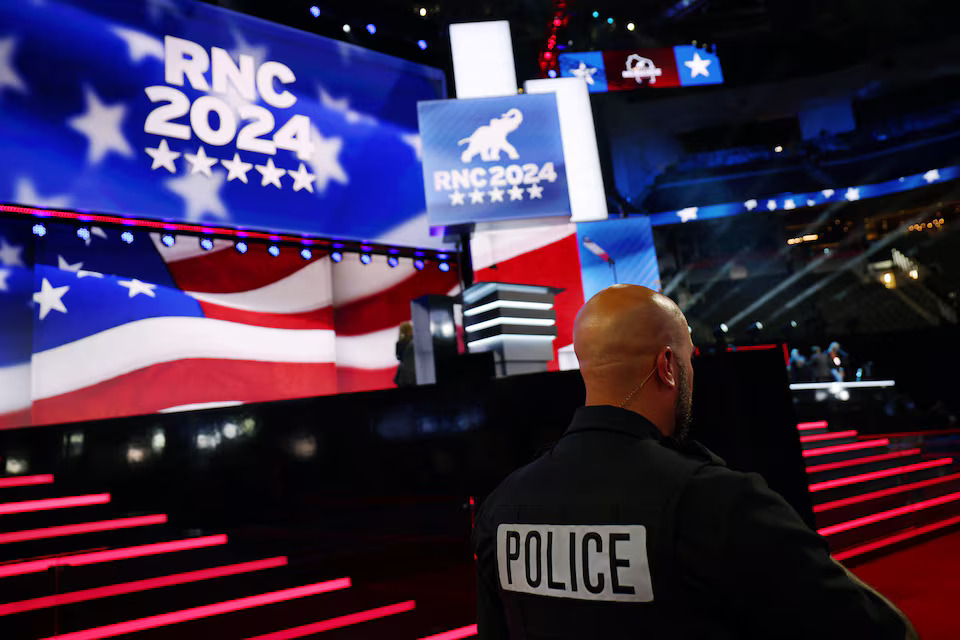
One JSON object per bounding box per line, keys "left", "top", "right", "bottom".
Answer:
{"left": 497, "top": 524, "right": 653, "bottom": 602}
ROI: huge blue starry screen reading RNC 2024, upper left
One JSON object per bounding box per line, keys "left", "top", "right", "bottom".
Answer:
{"left": 0, "top": 0, "right": 446, "bottom": 244}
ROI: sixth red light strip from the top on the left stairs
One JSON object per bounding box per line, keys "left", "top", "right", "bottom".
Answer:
{"left": 47, "top": 578, "right": 350, "bottom": 640}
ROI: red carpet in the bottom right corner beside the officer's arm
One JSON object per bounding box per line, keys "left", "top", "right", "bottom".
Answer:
{"left": 852, "top": 531, "right": 960, "bottom": 640}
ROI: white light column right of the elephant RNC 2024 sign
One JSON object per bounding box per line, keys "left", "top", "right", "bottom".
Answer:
{"left": 523, "top": 78, "right": 607, "bottom": 222}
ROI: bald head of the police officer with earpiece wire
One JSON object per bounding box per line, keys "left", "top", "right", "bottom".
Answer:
{"left": 573, "top": 285, "right": 693, "bottom": 435}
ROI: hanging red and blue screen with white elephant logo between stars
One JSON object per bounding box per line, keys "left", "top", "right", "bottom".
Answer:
{"left": 557, "top": 45, "right": 723, "bottom": 93}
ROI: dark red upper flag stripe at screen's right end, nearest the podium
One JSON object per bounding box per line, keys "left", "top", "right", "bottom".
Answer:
{"left": 333, "top": 265, "right": 458, "bottom": 336}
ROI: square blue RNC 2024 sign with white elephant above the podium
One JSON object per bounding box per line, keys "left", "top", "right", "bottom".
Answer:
{"left": 418, "top": 94, "right": 570, "bottom": 226}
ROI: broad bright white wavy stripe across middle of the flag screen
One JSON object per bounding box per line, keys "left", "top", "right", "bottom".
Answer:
{"left": 32, "top": 317, "right": 336, "bottom": 400}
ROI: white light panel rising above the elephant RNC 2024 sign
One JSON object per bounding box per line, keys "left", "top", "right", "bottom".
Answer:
{"left": 450, "top": 20, "right": 517, "bottom": 98}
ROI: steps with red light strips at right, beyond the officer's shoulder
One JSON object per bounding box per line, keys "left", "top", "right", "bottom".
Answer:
{"left": 797, "top": 421, "right": 960, "bottom": 562}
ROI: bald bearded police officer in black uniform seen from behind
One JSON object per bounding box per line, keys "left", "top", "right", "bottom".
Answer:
{"left": 474, "top": 285, "right": 916, "bottom": 640}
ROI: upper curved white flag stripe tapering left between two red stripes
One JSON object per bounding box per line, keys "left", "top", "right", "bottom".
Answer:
{"left": 186, "top": 258, "right": 333, "bottom": 313}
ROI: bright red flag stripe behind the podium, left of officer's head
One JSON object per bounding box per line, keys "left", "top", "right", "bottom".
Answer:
{"left": 476, "top": 233, "right": 583, "bottom": 370}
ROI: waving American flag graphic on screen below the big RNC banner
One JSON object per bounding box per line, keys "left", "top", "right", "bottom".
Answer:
{"left": 0, "top": 221, "right": 458, "bottom": 428}
